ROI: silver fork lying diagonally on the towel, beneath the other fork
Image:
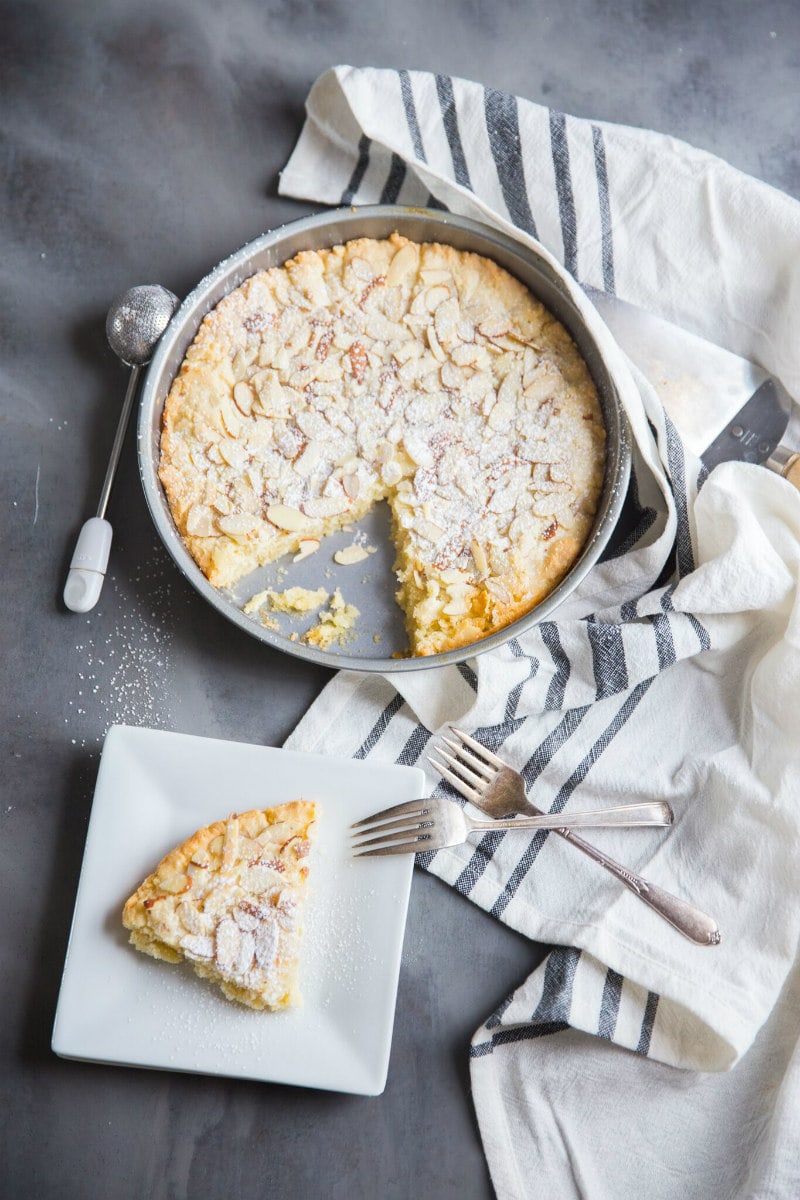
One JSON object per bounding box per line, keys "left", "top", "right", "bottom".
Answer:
{"left": 428, "top": 725, "right": 722, "bottom": 946}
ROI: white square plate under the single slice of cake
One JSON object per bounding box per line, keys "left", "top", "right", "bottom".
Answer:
{"left": 53, "top": 725, "right": 425, "bottom": 1096}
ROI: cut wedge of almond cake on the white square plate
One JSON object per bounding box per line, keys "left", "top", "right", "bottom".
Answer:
{"left": 122, "top": 800, "right": 317, "bottom": 1009}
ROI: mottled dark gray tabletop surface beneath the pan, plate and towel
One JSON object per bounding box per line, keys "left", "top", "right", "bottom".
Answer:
{"left": 0, "top": 0, "right": 800, "bottom": 1200}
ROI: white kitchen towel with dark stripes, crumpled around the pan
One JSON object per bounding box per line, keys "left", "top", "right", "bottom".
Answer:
{"left": 281, "top": 67, "right": 800, "bottom": 1200}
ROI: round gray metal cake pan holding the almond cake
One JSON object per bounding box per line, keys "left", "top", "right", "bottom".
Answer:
{"left": 138, "top": 206, "right": 631, "bottom": 672}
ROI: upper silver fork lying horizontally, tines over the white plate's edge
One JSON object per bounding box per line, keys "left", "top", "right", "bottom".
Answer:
{"left": 351, "top": 797, "right": 672, "bottom": 857}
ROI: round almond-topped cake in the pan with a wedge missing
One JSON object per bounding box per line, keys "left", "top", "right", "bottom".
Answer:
{"left": 160, "top": 233, "right": 606, "bottom": 655}
